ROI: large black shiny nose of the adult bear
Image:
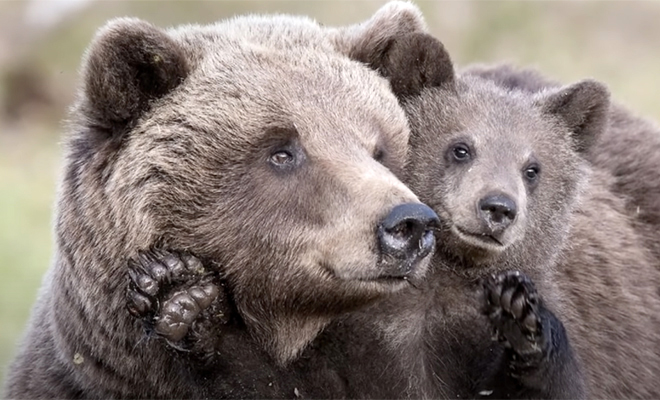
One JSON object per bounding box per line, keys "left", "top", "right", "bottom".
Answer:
{"left": 378, "top": 203, "right": 440, "bottom": 277}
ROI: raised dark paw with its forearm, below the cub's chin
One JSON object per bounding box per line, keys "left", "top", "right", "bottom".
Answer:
{"left": 480, "top": 271, "right": 586, "bottom": 399}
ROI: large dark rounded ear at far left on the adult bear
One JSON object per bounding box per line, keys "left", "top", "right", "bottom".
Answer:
{"left": 82, "top": 18, "right": 188, "bottom": 134}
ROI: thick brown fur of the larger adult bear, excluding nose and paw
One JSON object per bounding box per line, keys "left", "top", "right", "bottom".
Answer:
{"left": 5, "top": 4, "right": 444, "bottom": 398}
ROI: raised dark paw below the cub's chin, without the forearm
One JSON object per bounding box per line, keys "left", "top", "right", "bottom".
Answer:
{"left": 483, "top": 271, "right": 548, "bottom": 366}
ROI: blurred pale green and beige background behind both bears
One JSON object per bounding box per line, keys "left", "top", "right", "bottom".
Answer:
{"left": 0, "top": 0, "right": 660, "bottom": 382}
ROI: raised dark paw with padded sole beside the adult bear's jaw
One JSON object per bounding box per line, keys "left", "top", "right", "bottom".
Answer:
{"left": 127, "top": 250, "right": 224, "bottom": 342}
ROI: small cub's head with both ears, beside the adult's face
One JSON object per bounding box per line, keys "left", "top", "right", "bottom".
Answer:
{"left": 348, "top": 32, "right": 609, "bottom": 274}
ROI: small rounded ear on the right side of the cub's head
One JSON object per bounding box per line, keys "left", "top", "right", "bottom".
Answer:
{"left": 538, "top": 79, "right": 610, "bottom": 153}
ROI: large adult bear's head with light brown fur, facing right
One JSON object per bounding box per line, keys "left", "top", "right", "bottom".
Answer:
{"left": 57, "top": 11, "right": 437, "bottom": 362}
